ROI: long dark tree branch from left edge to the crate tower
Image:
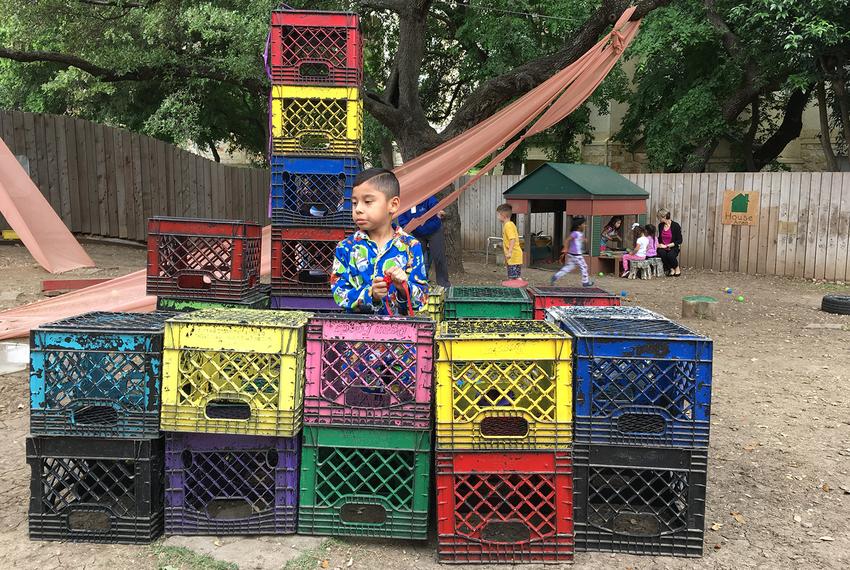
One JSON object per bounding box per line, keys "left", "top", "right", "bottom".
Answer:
{"left": 0, "top": 47, "right": 268, "bottom": 93}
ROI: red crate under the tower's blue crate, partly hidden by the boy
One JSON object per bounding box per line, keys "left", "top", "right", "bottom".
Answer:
{"left": 272, "top": 227, "right": 351, "bottom": 297}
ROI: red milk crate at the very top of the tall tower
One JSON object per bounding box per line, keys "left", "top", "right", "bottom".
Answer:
{"left": 268, "top": 10, "right": 363, "bottom": 87}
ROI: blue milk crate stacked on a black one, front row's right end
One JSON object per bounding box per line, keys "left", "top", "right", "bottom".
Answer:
{"left": 547, "top": 306, "right": 712, "bottom": 556}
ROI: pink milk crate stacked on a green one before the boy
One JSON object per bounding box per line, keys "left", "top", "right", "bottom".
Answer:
{"left": 298, "top": 313, "right": 434, "bottom": 540}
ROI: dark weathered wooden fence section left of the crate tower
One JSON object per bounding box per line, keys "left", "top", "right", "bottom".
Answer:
{"left": 0, "top": 110, "right": 269, "bottom": 237}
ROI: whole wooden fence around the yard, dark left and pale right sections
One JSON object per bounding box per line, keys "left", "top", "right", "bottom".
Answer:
{"left": 0, "top": 111, "right": 850, "bottom": 281}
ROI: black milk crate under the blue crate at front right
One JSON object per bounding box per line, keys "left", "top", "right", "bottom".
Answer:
{"left": 573, "top": 444, "right": 708, "bottom": 557}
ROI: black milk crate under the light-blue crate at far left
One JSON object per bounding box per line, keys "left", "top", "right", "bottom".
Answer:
{"left": 27, "top": 437, "right": 164, "bottom": 544}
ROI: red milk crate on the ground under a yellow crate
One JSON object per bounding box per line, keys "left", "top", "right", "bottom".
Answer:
{"left": 436, "top": 451, "right": 574, "bottom": 564}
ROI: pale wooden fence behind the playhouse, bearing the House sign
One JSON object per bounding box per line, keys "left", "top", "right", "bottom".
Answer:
{"left": 459, "top": 172, "right": 850, "bottom": 281}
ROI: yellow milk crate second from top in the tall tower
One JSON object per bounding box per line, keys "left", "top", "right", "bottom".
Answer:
{"left": 271, "top": 85, "right": 363, "bottom": 155}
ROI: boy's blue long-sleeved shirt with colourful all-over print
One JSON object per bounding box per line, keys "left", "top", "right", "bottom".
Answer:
{"left": 331, "top": 228, "right": 428, "bottom": 315}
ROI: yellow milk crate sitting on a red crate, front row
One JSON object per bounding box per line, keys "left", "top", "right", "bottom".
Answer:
{"left": 435, "top": 319, "right": 573, "bottom": 450}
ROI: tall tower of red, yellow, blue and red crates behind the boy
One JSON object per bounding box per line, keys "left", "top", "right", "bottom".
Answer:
{"left": 266, "top": 9, "right": 363, "bottom": 311}
